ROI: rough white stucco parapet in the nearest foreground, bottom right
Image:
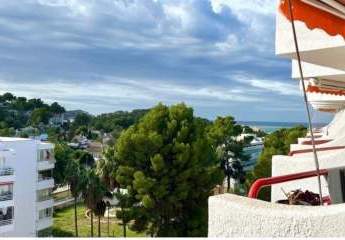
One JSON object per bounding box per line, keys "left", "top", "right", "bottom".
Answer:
{"left": 208, "top": 194, "right": 345, "bottom": 237}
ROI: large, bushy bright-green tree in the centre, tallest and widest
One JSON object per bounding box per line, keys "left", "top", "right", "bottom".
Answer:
{"left": 116, "top": 104, "right": 223, "bottom": 236}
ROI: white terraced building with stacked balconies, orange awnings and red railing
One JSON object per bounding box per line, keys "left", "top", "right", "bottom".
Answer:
{"left": 208, "top": 0, "right": 345, "bottom": 237}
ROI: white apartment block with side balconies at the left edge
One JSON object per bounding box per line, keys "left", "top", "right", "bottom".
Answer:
{"left": 0, "top": 137, "right": 55, "bottom": 237}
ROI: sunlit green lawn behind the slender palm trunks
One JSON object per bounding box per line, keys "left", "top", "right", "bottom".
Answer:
{"left": 53, "top": 203, "right": 145, "bottom": 237}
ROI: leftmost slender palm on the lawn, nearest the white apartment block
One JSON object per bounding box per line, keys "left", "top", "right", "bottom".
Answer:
{"left": 65, "top": 159, "right": 85, "bottom": 237}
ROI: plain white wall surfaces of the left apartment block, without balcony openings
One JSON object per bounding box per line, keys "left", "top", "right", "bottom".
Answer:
{"left": 0, "top": 137, "right": 54, "bottom": 237}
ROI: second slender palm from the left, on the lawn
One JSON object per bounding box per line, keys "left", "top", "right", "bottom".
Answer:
{"left": 83, "top": 169, "right": 105, "bottom": 237}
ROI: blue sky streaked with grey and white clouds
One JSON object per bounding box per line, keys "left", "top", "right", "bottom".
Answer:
{"left": 0, "top": 0, "right": 327, "bottom": 122}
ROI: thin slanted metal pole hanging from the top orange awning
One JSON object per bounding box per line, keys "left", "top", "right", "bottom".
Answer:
{"left": 288, "top": 0, "right": 323, "bottom": 205}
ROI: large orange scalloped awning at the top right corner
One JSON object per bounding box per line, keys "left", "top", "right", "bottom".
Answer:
{"left": 279, "top": 0, "right": 345, "bottom": 38}
